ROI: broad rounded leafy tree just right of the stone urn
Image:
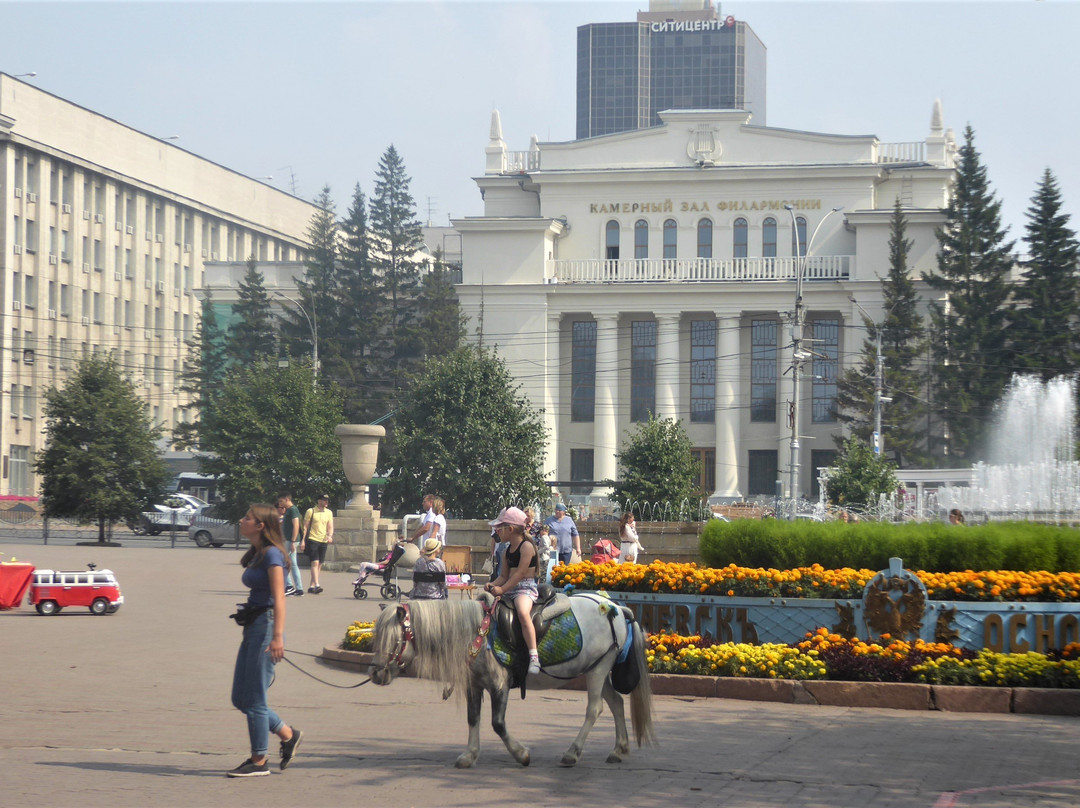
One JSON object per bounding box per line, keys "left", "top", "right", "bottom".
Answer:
{"left": 384, "top": 346, "right": 549, "bottom": 519}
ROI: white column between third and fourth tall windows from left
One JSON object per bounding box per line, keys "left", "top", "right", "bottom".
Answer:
{"left": 708, "top": 314, "right": 748, "bottom": 504}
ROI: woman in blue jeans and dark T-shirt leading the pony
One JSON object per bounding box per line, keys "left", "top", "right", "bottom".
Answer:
{"left": 226, "top": 504, "right": 303, "bottom": 777}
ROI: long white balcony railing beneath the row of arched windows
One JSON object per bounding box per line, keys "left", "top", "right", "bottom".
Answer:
{"left": 544, "top": 255, "right": 855, "bottom": 283}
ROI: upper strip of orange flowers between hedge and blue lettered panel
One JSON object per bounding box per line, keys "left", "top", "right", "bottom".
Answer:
{"left": 552, "top": 561, "right": 1080, "bottom": 603}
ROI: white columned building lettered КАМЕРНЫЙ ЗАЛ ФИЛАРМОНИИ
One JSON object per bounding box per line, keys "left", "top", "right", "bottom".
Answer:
{"left": 454, "top": 104, "right": 956, "bottom": 501}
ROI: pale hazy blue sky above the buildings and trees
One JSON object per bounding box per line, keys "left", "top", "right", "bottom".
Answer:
{"left": 0, "top": 0, "right": 1080, "bottom": 243}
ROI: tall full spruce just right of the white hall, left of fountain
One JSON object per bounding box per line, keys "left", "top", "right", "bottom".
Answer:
{"left": 926, "top": 126, "right": 1013, "bottom": 462}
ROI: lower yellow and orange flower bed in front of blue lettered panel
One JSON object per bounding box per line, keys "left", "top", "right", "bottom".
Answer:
{"left": 646, "top": 629, "right": 1080, "bottom": 688}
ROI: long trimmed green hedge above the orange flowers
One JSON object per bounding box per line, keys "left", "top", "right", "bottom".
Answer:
{"left": 700, "top": 520, "right": 1080, "bottom": 573}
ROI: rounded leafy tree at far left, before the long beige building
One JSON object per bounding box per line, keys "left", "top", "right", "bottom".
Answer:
{"left": 35, "top": 354, "right": 170, "bottom": 542}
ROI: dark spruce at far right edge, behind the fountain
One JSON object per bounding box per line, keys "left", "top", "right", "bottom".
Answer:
{"left": 1010, "top": 169, "right": 1080, "bottom": 380}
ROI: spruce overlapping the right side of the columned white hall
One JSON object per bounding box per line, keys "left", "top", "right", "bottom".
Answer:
{"left": 836, "top": 199, "right": 930, "bottom": 467}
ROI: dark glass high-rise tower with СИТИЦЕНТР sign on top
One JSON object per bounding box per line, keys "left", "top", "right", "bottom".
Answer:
{"left": 577, "top": 0, "right": 766, "bottom": 138}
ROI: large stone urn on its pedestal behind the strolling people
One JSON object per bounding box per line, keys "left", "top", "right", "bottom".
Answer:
{"left": 326, "top": 423, "right": 397, "bottom": 569}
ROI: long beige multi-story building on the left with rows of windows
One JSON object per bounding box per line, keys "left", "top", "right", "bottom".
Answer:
{"left": 0, "top": 73, "right": 314, "bottom": 496}
